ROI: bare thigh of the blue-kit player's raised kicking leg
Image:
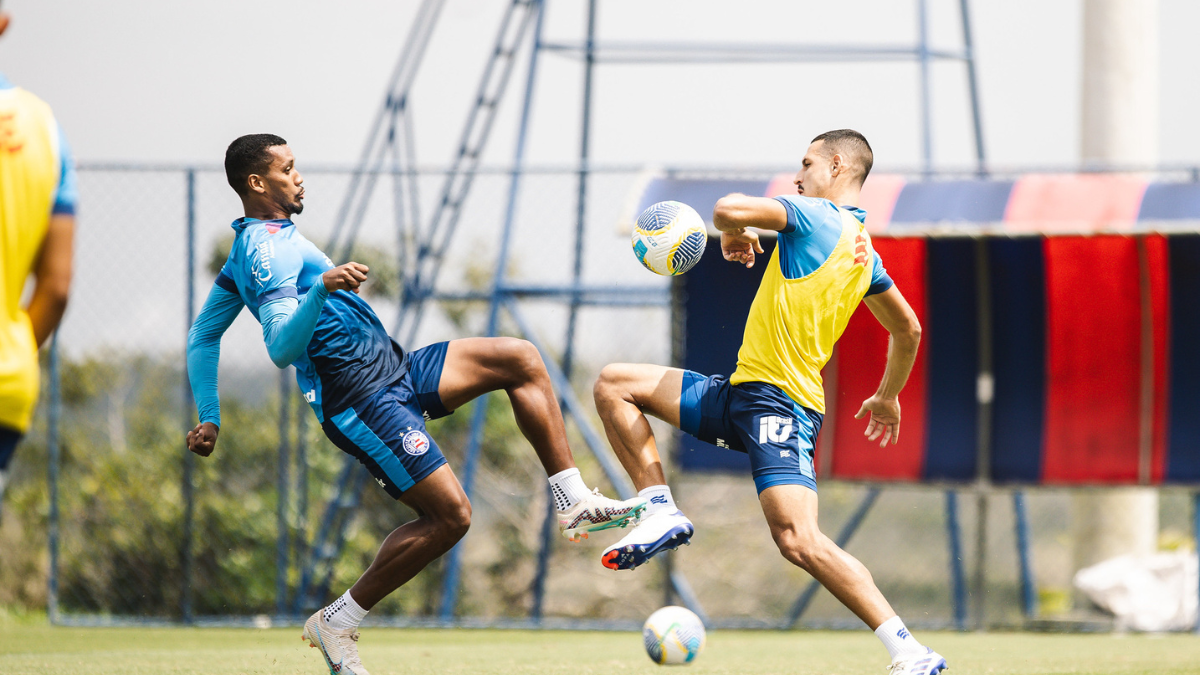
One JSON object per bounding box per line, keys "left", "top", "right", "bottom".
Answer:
{"left": 438, "top": 338, "right": 546, "bottom": 411}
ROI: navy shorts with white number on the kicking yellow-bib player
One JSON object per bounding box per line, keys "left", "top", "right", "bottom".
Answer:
{"left": 679, "top": 370, "right": 824, "bottom": 492}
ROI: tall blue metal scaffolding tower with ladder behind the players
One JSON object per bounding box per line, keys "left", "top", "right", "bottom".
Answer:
{"left": 297, "top": 0, "right": 986, "bottom": 622}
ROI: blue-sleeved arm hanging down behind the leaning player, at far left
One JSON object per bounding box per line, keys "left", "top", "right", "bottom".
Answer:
{"left": 187, "top": 283, "right": 242, "bottom": 456}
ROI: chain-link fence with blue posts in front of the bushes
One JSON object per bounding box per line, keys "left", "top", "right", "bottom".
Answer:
{"left": 0, "top": 167, "right": 1190, "bottom": 626}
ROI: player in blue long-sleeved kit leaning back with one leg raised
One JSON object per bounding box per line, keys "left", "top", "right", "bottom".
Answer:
{"left": 187, "top": 133, "right": 647, "bottom": 675}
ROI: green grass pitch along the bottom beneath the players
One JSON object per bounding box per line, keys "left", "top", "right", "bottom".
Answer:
{"left": 0, "top": 622, "right": 1200, "bottom": 675}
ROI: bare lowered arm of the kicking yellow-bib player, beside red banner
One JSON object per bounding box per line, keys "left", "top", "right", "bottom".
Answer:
{"left": 854, "top": 286, "right": 920, "bottom": 448}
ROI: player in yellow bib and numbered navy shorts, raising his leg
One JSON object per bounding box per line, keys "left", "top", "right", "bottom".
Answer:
{"left": 595, "top": 130, "right": 947, "bottom": 675}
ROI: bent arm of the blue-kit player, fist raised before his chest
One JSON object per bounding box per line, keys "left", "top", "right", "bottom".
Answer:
{"left": 258, "top": 263, "right": 368, "bottom": 368}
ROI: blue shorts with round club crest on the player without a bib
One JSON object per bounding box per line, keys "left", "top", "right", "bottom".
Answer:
{"left": 320, "top": 342, "right": 450, "bottom": 500}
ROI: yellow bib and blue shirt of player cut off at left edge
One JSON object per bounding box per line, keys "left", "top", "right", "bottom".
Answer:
{"left": 0, "top": 74, "right": 78, "bottom": 432}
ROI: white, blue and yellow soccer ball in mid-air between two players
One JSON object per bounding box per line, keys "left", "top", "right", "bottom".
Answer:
{"left": 634, "top": 202, "right": 708, "bottom": 276}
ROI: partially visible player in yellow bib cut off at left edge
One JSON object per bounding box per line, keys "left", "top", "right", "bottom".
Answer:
{"left": 0, "top": 2, "right": 76, "bottom": 511}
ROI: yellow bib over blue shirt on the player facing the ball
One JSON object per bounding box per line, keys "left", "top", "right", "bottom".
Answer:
{"left": 730, "top": 196, "right": 892, "bottom": 414}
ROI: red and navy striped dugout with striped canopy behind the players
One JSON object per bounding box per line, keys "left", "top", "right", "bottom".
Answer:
{"left": 667, "top": 174, "right": 1200, "bottom": 485}
